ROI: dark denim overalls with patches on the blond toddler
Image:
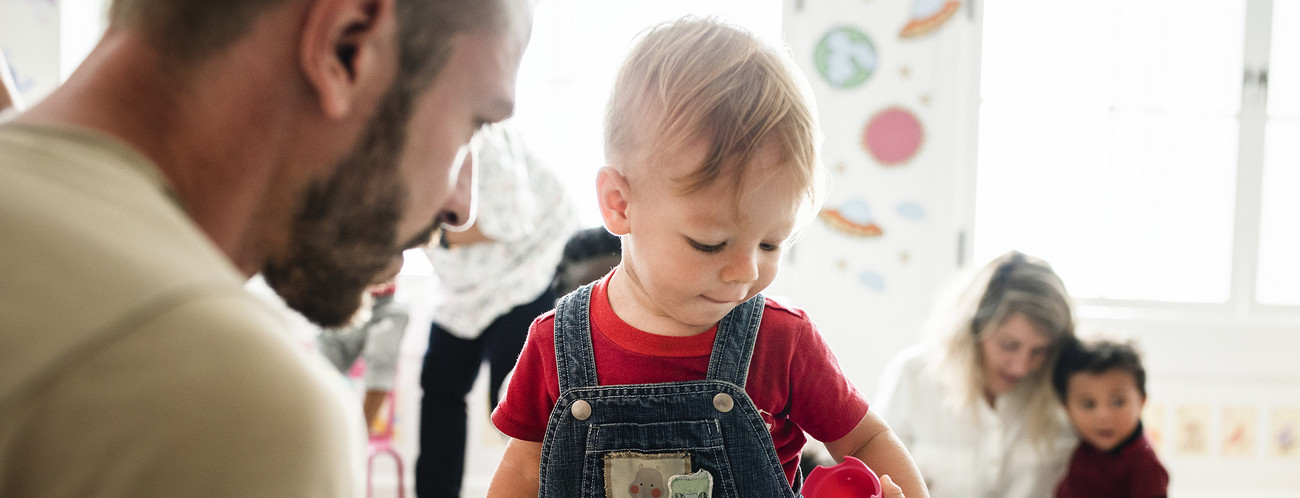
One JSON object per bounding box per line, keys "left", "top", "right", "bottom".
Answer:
{"left": 540, "top": 285, "right": 802, "bottom": 498}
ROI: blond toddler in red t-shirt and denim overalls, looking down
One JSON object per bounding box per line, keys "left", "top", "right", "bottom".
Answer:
{"left": 489, "top": 18, "right": 927, "bottom": 498}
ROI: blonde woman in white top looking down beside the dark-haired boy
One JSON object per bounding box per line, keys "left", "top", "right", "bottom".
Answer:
{"left": 872, "top": 251, "right": 1075, "bottom": 498}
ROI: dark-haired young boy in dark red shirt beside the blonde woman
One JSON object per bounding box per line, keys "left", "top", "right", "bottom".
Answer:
{"left": 1052, "top": 341, "right": 1169, "bottom": 498}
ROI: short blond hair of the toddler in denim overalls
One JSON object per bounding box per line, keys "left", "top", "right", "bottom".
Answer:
{"left": 605, "top": 17, "right": 820, "bottom": 203}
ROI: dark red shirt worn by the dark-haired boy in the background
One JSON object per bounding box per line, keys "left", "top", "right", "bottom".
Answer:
{"left": 1057, "top": 424, "right": 1169, "bottom": 498}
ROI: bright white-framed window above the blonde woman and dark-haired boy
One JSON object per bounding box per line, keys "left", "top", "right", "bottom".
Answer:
{"left": 974, "top": 0, "right": 1300, "bottom": 314}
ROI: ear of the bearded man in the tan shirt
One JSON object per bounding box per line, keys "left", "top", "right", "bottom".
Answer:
{"left": 299, "top": 0, "right": 398, "bottom": 118}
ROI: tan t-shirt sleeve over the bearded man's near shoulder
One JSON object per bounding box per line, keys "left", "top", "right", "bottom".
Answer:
{"left": 0, "top": 293, "right": 351, "bottom": 495}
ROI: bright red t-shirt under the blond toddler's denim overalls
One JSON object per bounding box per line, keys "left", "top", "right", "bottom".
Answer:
{"left": 491, "top": 273, "right": 867, "bottom": 482}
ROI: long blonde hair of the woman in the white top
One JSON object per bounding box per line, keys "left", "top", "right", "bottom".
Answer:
{"left": 927, "top": 251, "right": 1075, "bottom": 445}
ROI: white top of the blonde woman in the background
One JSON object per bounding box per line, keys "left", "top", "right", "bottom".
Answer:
{"left": 871, "top": 345, "right": 1078, "bottom": 498}
